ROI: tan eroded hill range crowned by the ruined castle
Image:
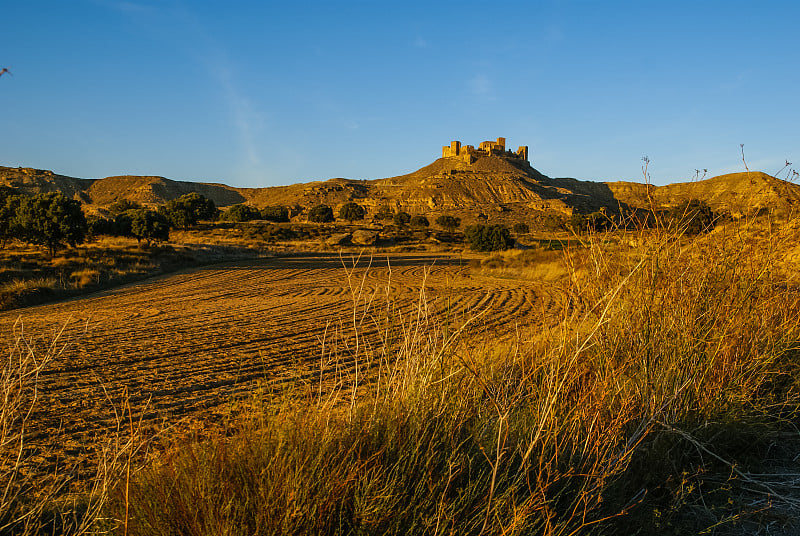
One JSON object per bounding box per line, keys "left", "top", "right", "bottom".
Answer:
{"left": 0, "top": 138, "right": 800, "bottom": 221}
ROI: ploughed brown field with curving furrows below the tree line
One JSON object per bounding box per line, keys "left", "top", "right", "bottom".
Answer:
{"left": 0, "top": 253, "right": 543, "bottom": 480}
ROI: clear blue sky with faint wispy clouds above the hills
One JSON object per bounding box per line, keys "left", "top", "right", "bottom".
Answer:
{"left": 0, "top": 0, "right": 800, "bottom": 187}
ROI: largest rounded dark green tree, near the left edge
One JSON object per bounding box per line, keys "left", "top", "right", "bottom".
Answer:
{"left": 15, "top": 192, "right": 86, "bottom": 257}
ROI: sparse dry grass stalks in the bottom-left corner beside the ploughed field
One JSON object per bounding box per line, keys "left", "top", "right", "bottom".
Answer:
{"left": 0, "top": 320, "right": 143, "bottom": 535}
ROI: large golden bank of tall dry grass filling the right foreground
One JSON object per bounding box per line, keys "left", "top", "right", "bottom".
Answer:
{"left": 115, "top": 217, "right": 800, "bottom": 535}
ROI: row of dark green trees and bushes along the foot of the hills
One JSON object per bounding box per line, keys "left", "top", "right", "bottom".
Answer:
{"left": 0, "top": 186, "right": 720, "bottom": 256}
